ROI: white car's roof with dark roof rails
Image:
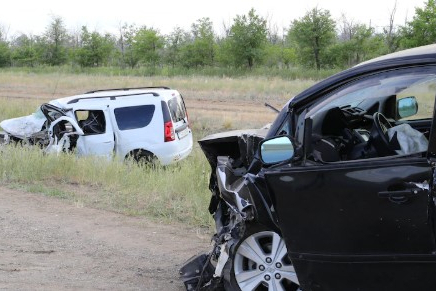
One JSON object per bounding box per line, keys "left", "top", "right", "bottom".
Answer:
{"left": 50, "top": 87, "right": 180, "bottom": 108}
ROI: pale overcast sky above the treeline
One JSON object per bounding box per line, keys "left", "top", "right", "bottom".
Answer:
{"left": 0, "top": 0, "right": 427, "bottom": 37}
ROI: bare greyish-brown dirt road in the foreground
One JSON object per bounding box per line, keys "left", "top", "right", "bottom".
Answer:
{"left": 0, "top": 186, "right": 210, "bottom": 291}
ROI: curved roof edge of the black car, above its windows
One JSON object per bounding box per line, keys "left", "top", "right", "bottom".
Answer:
{"left": 289, "top": 44, "right": 436, "bottom": 107}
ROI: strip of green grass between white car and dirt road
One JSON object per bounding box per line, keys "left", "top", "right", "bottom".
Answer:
{"left": 0, "top": 145, "right": 211, "bottom": 226}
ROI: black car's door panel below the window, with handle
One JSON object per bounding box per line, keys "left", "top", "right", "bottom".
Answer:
{"left": 266, "top": 157, "right": 436, "bottom": 290}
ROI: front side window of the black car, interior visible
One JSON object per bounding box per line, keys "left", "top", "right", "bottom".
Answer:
{"left": 300, "top": 66, "right": 436, "bottom": 162}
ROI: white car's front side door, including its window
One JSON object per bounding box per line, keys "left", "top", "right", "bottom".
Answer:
{"left": 74, "top": 106, "right": 115, "bottom": 157}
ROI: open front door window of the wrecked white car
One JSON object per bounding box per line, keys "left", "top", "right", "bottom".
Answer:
{"left": 75, "top": 110, "right": 106, "bottom": 135}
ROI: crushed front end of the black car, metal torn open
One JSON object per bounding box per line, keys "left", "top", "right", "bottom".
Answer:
{"left": 180, "top": 129, "right": 296, "bottom": 290}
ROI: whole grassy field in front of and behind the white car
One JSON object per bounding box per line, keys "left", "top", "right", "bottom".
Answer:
{"left": 0, "top": 71, "right": 314, "bottom": 227}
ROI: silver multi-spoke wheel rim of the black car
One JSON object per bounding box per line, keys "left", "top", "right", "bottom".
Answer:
{"left": 234, "top": 231, "right": 298, "bottom": 291}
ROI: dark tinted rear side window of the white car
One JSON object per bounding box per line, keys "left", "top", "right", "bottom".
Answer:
{"left": 114, "top": 105, "right": 155, "bottom": 130}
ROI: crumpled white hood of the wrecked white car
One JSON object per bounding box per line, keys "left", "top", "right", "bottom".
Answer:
{"left": 0, "top": 114, "right": 47, "bottom": 138}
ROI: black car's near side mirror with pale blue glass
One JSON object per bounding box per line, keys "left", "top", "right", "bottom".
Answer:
{"left": 260, "top": 136, "right": 295, "bottom": 164}
